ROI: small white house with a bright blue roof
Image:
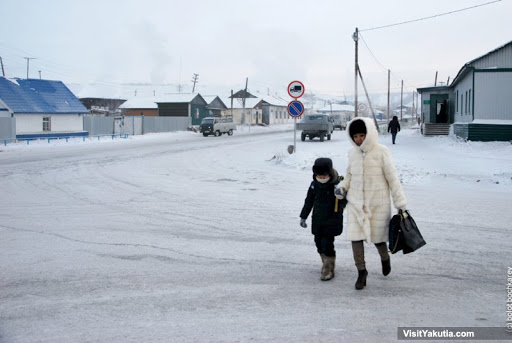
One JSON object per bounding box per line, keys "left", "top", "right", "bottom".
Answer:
{"left": 0, "top": 77, "right": 89, "bottom": 138}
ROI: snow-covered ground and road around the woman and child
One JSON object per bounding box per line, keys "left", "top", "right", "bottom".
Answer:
{"left": 0, "top": 127, "right": 512, "bottom": 343}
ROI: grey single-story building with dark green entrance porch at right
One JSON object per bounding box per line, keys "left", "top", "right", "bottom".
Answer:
{"left": 418, "top": 41, "right": 512, "bottom": 141}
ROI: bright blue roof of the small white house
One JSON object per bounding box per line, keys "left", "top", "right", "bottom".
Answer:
{"left": 0, "top": 77, "right": 89, "bottom": 114}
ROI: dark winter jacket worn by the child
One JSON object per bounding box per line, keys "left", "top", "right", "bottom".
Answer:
{"left": 300, "top": 168, "right": 346, "bottom": 236}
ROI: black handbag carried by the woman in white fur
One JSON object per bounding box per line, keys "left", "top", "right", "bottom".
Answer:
{"left": 389, "top": 210, "right": 427, "bottom": 254}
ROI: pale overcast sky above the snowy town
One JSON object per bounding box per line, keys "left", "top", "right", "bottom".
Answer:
{"left": 0, "top": 0, "right": 512, "bottom": 96}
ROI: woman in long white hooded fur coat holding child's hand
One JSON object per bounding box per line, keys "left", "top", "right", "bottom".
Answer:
{"left": 336, "top": 117, "right": 407, "bottom": 290}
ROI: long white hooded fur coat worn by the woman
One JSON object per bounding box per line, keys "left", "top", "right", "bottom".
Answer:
{"left": 338, "top": 117, "right": 407, "bottom": 243}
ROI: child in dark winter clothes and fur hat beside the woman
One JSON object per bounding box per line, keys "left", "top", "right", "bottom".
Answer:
{"left": 300, "top": 157, "right": 346, "bottom": 281}
